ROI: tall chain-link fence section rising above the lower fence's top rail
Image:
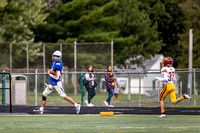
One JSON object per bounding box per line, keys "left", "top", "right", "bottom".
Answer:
{"left": 0, "top": 41, "right": 114, "bottom": 70}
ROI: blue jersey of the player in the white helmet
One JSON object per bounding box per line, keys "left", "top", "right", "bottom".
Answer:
{"left": 49, "top": 61, "right": 62, "bottom": 85}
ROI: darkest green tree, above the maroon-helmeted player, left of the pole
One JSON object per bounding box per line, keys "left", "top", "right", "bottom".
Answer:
{"left": 141, "top": 0, "right": 185, "bottom": 67}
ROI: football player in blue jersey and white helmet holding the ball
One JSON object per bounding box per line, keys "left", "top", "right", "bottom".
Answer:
{"left": 36, "top": 51, "right": 81, "bottom": 114}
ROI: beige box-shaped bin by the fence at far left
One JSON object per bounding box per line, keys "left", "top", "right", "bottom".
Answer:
{"left": 6, "top": 75, "right": 27, "bottom": 105}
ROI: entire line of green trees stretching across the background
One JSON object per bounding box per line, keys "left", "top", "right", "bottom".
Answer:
{"left": 0, "top": 0, "right": 200, "bottom": 68}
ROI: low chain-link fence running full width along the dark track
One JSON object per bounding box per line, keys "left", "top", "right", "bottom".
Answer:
{"left": 0, "top": 70, "right": 200, "bottom": 107}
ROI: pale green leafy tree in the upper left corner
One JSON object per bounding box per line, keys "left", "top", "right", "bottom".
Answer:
{"left": 0, "top": 0, "right": 47, "bottom": 68}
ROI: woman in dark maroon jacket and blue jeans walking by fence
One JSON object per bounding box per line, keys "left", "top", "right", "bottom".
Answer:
{"left": 104, "top": 65, "right": 116, "bottom": 107}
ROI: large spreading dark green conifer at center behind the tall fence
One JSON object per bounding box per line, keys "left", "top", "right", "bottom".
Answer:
{"left": 35, "top": 0, "right": 163, "bottom": 66}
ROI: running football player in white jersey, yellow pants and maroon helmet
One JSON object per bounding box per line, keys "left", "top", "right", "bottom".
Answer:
{"left": 155, "top": 57, "right": 191, "bottom": 118}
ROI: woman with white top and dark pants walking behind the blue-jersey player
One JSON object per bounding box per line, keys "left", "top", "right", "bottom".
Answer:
{"left": 85, "top": 65, "right": 96, "bottom": 107}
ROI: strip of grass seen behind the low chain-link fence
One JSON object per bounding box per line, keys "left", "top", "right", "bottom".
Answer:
{"left": 0, "top": 90, "right": 197, "bottom": 107}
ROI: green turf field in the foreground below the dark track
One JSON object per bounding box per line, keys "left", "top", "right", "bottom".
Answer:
{"left": 0, "top": 115, "right": 200, "bottom": 133}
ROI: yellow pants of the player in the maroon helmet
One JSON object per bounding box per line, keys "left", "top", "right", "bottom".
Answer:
{"left": 160, "top": 84, "right": 176, "bottom": 103}
